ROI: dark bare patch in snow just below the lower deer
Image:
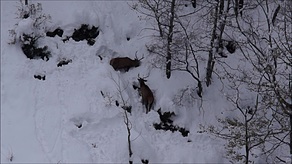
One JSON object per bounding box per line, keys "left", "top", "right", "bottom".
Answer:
{"left": 153, "top": 109, "right": 190, "bottom": 137}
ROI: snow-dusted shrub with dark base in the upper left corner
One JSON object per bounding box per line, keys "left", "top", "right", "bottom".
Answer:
{"left": 9, "top": 1, "right": 51, "bottom": 60}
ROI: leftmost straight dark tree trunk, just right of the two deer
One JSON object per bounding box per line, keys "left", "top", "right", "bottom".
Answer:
{"left": 166, "top": 0, "right": 175, "bottom": 79}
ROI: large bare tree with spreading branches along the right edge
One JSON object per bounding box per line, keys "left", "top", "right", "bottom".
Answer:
{"left": 236, "top": 0, "right": 292, "bottom": 161}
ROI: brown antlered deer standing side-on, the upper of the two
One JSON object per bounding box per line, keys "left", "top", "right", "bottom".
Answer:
{"left": 110, "top": 52, "right": 144, "bottom": 72}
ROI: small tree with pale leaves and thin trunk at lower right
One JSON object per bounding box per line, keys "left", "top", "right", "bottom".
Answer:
{"left": 208, "top": 82, "right": 288, "bottom": 164}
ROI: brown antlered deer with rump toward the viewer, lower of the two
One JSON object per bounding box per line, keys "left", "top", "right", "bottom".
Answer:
{"left": 133, "top": 74, "right": 154, "bottom": 114}
